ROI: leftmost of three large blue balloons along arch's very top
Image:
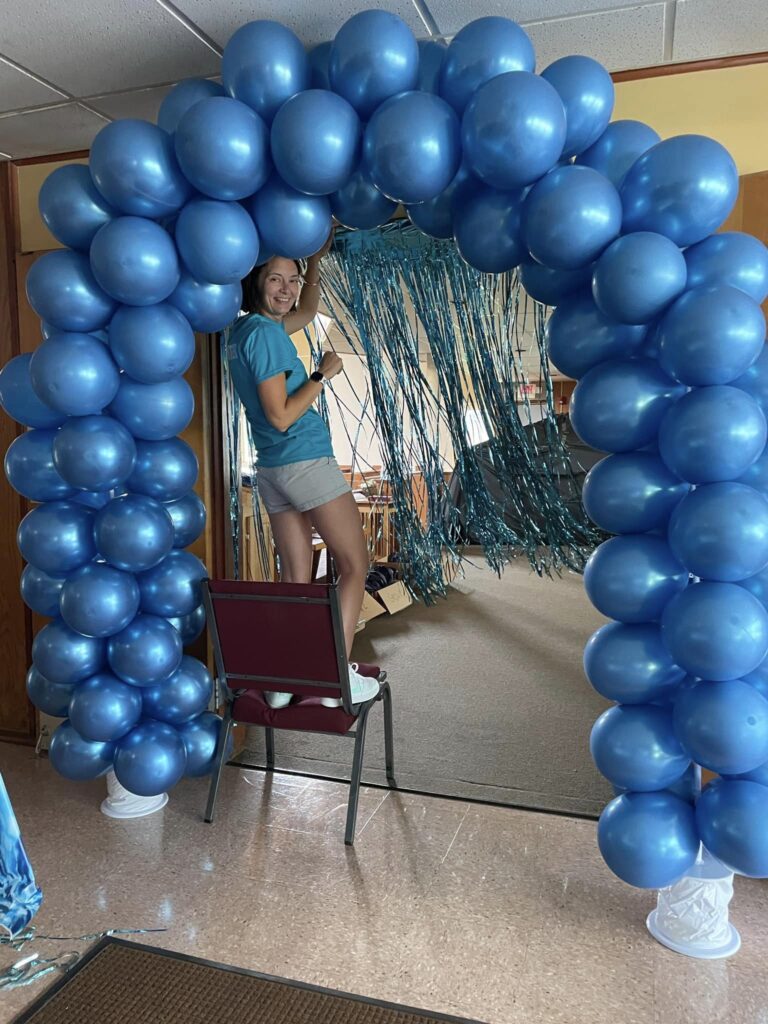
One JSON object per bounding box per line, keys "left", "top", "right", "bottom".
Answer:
{"left": 221, "top": 19, "right": 309, "bottom": 124}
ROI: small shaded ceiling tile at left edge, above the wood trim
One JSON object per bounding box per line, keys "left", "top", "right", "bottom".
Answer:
{"left": 0, "top": 103, "right": 106, "bottom": 160}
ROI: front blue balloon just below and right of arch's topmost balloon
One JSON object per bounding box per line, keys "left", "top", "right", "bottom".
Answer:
{"left": 362, "top": 92, "right": 462, "bottom": 203}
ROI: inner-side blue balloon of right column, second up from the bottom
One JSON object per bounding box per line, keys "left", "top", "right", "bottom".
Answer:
{"left": 590, "top": 697, "right": 696, "bottom": 793}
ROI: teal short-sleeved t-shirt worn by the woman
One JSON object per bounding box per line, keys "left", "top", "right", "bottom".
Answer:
{"left": 226, "top": 313, "right": 333, "bottom": 466}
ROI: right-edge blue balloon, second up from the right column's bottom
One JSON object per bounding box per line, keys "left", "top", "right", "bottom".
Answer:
{"left": 674, "top": 679, "right": 768, "bottom": 775}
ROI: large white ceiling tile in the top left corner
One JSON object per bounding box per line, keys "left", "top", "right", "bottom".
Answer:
{"left": 0, "top": 0, "right": 219, "bottom": 96}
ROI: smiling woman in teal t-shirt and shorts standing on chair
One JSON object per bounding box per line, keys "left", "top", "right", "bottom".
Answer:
{"left": 227, "top": 236, "right": 379, "bottom": 708}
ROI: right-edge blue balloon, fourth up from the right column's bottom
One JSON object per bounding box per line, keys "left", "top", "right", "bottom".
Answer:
{"left": 669, "top": 481, "right": 768, "bottom": 585}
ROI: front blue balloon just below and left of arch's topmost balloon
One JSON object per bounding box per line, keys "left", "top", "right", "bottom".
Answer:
{"left": 272, "top": 89, "right": 360, "bottom": 195}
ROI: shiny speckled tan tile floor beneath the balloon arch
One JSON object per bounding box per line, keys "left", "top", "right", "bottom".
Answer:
{"left": 0, "top": 744, "right": 768, "bottom": 1024}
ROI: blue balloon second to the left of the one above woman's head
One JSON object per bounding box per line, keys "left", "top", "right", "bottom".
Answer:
{"left": 90, "top": 217, "right": 179, "bottom": 306}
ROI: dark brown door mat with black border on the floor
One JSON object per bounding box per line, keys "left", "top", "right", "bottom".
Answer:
{"left": 14, "top": 938, "right": 489, "bottom": 1024}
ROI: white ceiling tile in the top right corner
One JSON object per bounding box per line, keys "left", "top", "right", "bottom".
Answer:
{"left": 672, "top": 0, "right": 768, "bottom": 60}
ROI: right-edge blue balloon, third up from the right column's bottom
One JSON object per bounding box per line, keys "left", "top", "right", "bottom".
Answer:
{"left": 662, "top": 583, "right": 768, "bottom": 681}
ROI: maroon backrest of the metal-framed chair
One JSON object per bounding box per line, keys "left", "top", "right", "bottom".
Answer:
{"left": 203, "top": 580, "right": 351, "bottom": 708}
